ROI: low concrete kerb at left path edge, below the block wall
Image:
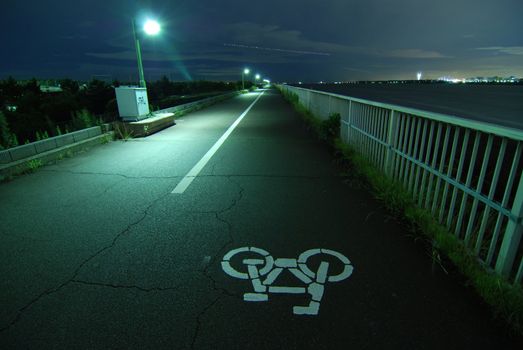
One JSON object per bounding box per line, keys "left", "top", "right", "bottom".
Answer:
{"left": 0, "top": 131, "right": 114, "bottom": 180}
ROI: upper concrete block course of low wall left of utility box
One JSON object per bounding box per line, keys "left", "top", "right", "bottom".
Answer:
{"left": 0, "top": 126, "right": 102, "bottom": 164}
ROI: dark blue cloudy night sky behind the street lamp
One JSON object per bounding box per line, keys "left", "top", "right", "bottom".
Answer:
{"left": 0, "top": 0, "right": 523, "bottom": 82}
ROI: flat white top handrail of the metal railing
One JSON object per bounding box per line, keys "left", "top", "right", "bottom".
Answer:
{"left": 287, "top": 85, "right": 523, "bottom": 141}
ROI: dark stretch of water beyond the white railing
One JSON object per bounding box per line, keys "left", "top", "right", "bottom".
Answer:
{"left": 296, "top": 84, "right": 523, "bottom": 130}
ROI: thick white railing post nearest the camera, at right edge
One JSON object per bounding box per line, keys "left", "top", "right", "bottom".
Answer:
{"left": 496, "top": 176, "right": 523, "bottom": 277}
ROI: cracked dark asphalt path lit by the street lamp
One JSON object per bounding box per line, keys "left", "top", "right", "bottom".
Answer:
{"left": 0, "top": 90, "right": 522, "bottom": 349}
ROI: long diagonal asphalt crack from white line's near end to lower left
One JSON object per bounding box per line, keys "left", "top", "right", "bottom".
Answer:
{"left": 0, "top": 192, "right": 170, "bottom": 333}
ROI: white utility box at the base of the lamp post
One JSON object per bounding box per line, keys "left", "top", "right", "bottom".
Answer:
{"left": 115, "top": 86, "right": 149, "bottom": 121}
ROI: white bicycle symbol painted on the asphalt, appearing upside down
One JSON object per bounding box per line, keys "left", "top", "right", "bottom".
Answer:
{"left": 222, "top": 247, "right": 354, "bottom": 315}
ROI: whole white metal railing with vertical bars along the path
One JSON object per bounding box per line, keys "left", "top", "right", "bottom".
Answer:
{"left": 279, "top": 85, "right": 523, "bottom": 284}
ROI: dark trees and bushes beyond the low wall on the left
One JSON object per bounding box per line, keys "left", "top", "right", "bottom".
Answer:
{"left": 0, "top": 77, "right": 252, "bottom": 150}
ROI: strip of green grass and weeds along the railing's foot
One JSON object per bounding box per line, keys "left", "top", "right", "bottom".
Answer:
{"left": 282, "top": 86, "right": 523, "bottom": 335}
